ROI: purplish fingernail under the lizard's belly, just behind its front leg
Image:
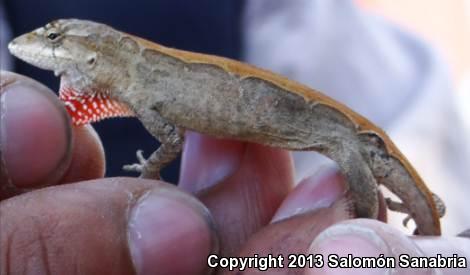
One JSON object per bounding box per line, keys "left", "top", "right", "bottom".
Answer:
{"left": 178, "top": 131, "right": 245, "bottom": 193}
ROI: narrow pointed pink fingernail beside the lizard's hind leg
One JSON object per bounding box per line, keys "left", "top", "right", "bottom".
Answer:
{"left": 272, "top": 166, "right": 345, "bottom": 222}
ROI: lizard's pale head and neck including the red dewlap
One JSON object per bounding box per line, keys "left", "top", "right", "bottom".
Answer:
{"left": 8, "top": 19, "right": 133, "bottom": 125}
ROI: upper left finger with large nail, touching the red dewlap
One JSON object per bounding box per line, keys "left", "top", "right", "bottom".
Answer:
{"left": 0, "top": 72, "right": 104, "bottom": 198}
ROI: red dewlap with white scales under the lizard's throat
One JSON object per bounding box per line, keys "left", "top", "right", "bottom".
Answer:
{"left": 59, "top": 87, "right": 134, "bottom": 126}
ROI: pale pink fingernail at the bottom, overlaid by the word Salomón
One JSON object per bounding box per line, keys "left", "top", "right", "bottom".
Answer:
{"left": 306, "top": 224, "right": 393, "bottom": 275}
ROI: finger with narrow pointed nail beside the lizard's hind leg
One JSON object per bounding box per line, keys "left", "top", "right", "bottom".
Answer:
{"left": 218, "top": 171, "right": 388, "bottom": 274}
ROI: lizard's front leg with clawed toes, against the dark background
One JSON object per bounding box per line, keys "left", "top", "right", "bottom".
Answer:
{"left": 123, "top": 111, "right": 184, "bottom": 179}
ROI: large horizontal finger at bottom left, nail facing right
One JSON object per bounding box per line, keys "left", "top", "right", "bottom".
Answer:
{"left": 0, "top": 178, "right": 216, "bottom": 274}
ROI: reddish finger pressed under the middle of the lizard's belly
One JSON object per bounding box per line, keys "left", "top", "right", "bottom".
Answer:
{"left": 180, "top": 133, "right": 293, "bottom": 255}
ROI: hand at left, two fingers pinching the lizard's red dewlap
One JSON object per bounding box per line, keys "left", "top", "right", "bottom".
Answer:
{"left": 0, "top": 72, "right": 215, "bottom": 274}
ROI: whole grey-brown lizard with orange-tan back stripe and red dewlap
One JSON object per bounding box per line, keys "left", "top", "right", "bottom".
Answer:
{"left": 8, "top": 19, "right": 445, "bottom": 235}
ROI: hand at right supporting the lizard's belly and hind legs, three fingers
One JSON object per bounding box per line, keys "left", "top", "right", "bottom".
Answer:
{"left": 179, "top": 133, "right": 470, "bottom": 274}
